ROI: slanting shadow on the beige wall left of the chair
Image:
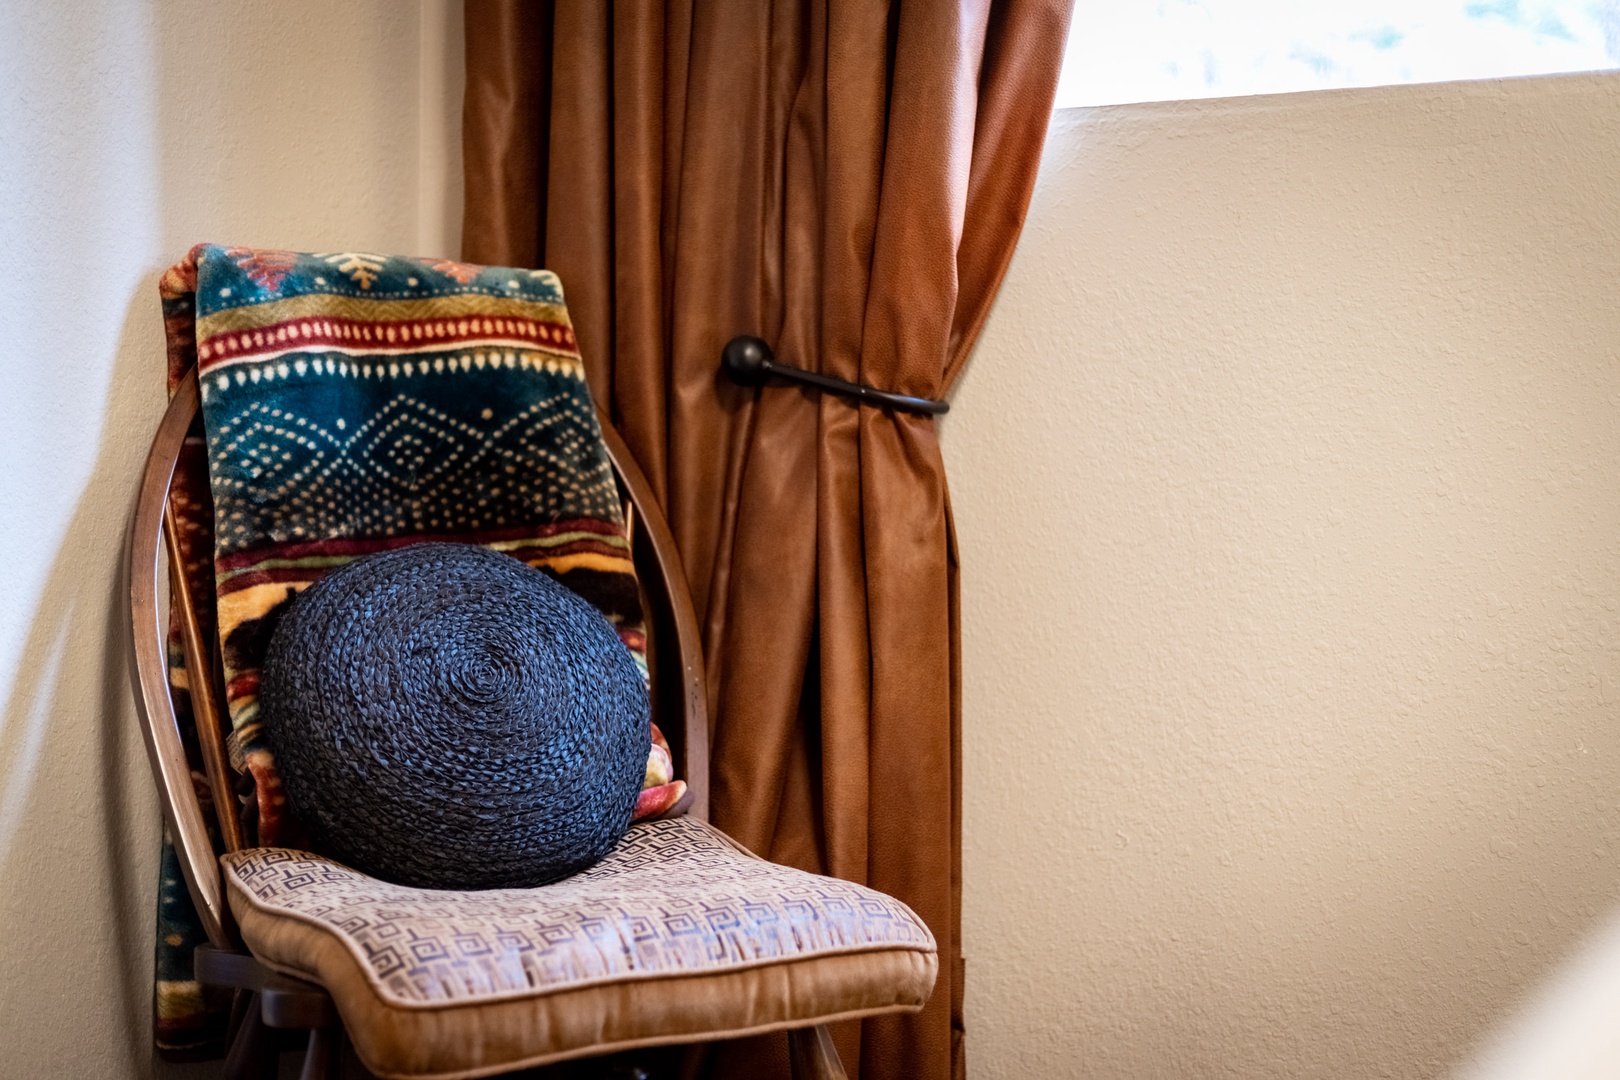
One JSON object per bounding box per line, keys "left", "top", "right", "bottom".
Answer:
{"left": 0, "top": 281, "right": 217, "bottom": 1077}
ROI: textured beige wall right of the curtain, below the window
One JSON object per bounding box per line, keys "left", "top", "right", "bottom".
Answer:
{"left": 943, "top": 76, "right": 1620, "bottom": 1080}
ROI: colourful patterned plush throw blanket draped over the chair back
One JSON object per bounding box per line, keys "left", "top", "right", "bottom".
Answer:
{"left": 157, "top": 244, "right": 685, "bottom": 1056}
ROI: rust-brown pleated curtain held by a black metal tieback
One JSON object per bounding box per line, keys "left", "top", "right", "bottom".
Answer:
{"left": 463, "top": 0, "right": 1071, "bottom": 1078}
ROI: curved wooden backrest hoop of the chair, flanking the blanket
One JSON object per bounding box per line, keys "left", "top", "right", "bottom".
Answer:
{"left": 128, "top": 369, "right": 710, "bottom": 947}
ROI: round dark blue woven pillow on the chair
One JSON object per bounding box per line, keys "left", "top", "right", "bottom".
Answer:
{"left": 259, "top": 544, "right": 651, "bottom": 889}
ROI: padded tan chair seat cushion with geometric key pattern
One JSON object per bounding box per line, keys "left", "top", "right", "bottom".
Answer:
{"left": 220, "top": 818, "right": 938, "bottom": 1080}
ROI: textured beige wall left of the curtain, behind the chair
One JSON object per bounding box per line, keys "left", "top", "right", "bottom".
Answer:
{"left": 0, "top": 0, "right": 460, "bottom": 1080}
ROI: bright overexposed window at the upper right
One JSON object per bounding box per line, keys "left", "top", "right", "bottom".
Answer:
{"left": 1058, "top": 0, "right": 1620, "bottom": 108}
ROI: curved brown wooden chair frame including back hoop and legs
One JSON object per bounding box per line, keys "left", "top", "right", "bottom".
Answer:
{"left": 128, "top": 369, "right": 844, "bottom": 1080}
